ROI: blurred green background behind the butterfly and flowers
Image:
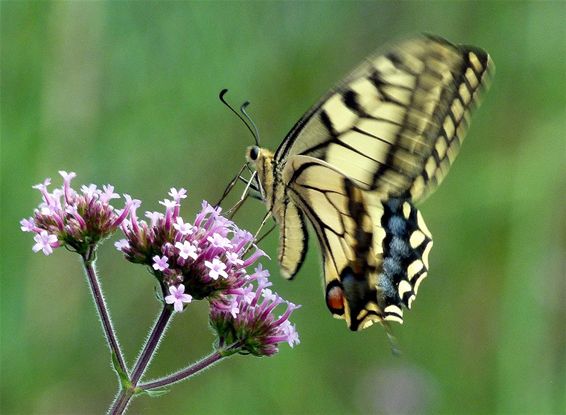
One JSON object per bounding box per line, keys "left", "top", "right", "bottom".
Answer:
{"left": 0, "top": 1, "right": 566, "bottom": 414}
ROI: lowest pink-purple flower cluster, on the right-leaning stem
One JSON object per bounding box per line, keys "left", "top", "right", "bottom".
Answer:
{"left": 210, "top": 264, "right": 299, "bottom": 356}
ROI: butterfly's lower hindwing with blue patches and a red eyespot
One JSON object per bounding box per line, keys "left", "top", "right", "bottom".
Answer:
{"left": 283, "top": 156, "right": 432, "bottom": 330}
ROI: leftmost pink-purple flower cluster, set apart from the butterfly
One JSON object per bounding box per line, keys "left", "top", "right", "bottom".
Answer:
{"left": 20, "top": 171, "right": 133, "bottom": 255}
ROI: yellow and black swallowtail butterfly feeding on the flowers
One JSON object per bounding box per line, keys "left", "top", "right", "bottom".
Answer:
{"left": 239, "top": 35, "right": 493, "bottom": 331}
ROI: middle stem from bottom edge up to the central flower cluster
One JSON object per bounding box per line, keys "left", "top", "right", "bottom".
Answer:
{"left": 108, "top": 306, "right": 173, "bottom": 415}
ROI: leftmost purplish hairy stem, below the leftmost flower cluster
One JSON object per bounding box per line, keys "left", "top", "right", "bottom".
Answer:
{"left": 81, "top": 247, "right": 128, "bottom": 375}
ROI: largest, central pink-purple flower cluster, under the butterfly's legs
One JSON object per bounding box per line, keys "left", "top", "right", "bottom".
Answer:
{"left": 116, "top": 188, "right": 265, "bottom": 304}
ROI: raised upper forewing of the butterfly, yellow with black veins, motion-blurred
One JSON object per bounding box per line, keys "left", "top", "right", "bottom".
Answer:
{"left": 275, "top": 35, "right": 493, "bottom": 202}
